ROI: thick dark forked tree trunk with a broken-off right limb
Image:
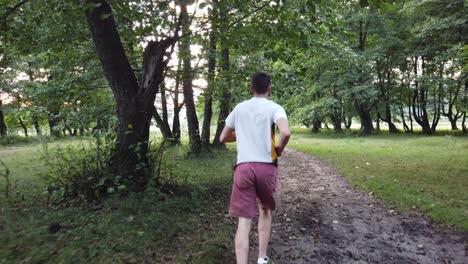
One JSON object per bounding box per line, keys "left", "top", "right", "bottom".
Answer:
{"left": 86, "top": 0, "right": 175, "bottom": 191}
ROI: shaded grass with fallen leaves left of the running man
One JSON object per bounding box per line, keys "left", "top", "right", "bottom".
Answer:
{"left": 0, "top": 141, "right": 235, "bottom": 263}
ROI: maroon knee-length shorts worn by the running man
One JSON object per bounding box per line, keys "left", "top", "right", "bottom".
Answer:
{"left": 229, "top": 162, "right": 277, "bottom": 218}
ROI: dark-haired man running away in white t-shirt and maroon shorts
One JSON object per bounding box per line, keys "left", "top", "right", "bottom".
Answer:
{"left": 220, "top": 72, "right": 291, "bottom": 264}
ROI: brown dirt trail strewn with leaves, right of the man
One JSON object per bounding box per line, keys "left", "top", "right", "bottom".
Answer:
{"left": 250, "top": 150, "right": 468, "bottom": 264}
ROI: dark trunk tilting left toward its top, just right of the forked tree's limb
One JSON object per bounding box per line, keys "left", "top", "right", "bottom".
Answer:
{"left": 180, "top": 3, "right": 201, "bottom": 153}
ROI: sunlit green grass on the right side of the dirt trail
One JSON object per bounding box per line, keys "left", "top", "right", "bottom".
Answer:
{"left": 290, "top": 129, "right": 468, "bottom": 230}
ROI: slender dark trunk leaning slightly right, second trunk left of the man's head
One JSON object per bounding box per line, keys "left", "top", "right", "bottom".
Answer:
{"left": 201, "top": 1, "right": 218, "bottom": 149}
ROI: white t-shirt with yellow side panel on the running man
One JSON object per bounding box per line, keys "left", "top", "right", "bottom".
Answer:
{"left": 226, "top": 97, "right": 287, "bottom": 164}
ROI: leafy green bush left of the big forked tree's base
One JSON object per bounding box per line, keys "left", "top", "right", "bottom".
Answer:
{"left": 40, "top": 133, "right": 118, "bottom": 201}
